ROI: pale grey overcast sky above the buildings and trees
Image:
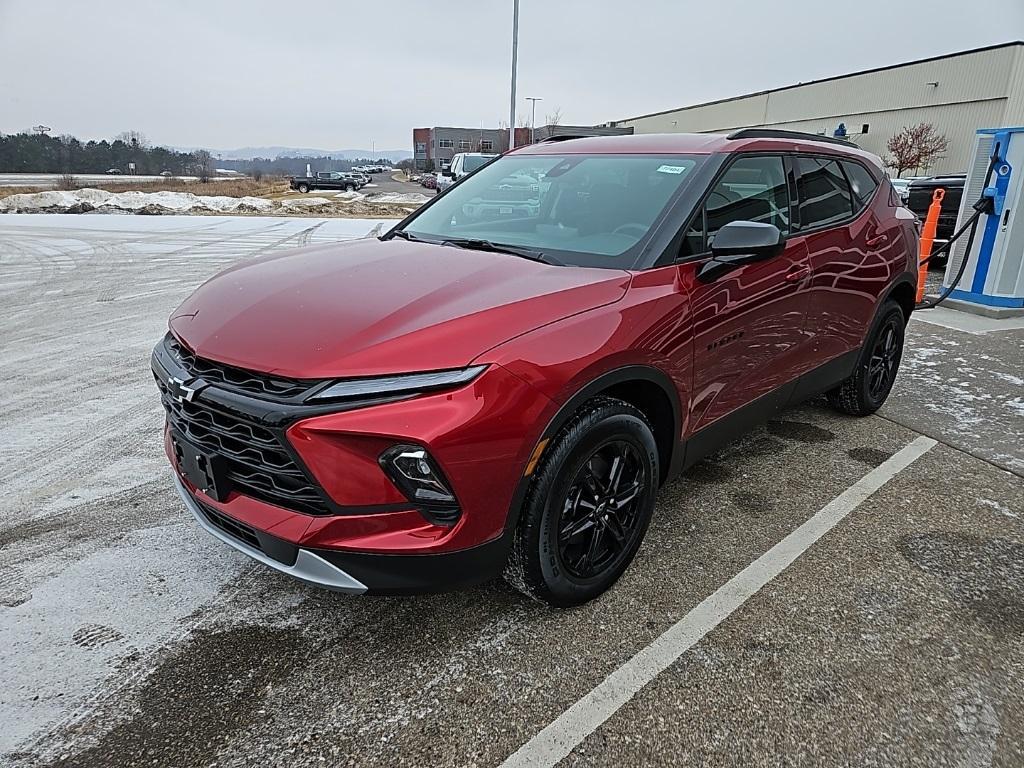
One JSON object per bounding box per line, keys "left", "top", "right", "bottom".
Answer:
{"left": 0, "top": 0, "right": 1024, "bottom": 150}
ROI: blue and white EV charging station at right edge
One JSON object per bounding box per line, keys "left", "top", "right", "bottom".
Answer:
{"left": 943, "top": 127, "right": 1024, "bottom": 317}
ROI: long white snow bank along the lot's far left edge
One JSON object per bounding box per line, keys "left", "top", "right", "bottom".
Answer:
{"left": 0, "top": 188, "right": 274, "bottom": 213}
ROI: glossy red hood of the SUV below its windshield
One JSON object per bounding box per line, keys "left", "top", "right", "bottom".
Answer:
{"left": 170, "top": 239, "right": 630, "bottom": 379}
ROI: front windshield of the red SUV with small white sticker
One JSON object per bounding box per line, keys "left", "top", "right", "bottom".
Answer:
{"left": 404, "top": 155, "right": 700, "bottom": 268}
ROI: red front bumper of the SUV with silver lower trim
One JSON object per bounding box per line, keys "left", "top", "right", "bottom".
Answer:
{"left": 153, "top": 333, "right": 553, "bottom": 593}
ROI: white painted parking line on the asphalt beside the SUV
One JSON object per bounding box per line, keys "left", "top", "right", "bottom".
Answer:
{"left": 502, "top": 437, "right": 937, "bottom": 768}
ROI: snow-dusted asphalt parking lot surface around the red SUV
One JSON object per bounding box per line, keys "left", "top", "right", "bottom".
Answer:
{"left": 0, "top": 215, "right": 1024, "bottom": 766}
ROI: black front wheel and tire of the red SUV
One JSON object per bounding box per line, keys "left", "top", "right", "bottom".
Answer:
{"left": 505, "top": 397, "right": 658, "bottom": 607}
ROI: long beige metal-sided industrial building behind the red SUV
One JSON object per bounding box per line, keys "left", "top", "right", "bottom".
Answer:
{"left": 608, "top": 41, "right": 1024, "bottom": 173}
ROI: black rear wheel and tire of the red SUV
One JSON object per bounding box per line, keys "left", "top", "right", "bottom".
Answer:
{"left": 826, "top": 301, "right": 906, "bottom": 416}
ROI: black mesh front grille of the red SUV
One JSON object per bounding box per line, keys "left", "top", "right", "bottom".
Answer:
{"left": 156, "top": 377, "right": 328, "bottom": 515}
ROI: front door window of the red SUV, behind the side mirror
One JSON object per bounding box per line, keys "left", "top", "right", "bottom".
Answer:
{"left": 705, "top": 156, "right": 790, "bottom": 245}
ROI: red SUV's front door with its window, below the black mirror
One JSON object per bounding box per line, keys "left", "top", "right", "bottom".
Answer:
{"left": 683, "top": 155, "right": 810, "bottom": 431}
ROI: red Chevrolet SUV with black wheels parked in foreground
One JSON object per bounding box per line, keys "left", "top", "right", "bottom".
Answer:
{"left": 153, "top": 130, "right": 916, "bottom": 605}
